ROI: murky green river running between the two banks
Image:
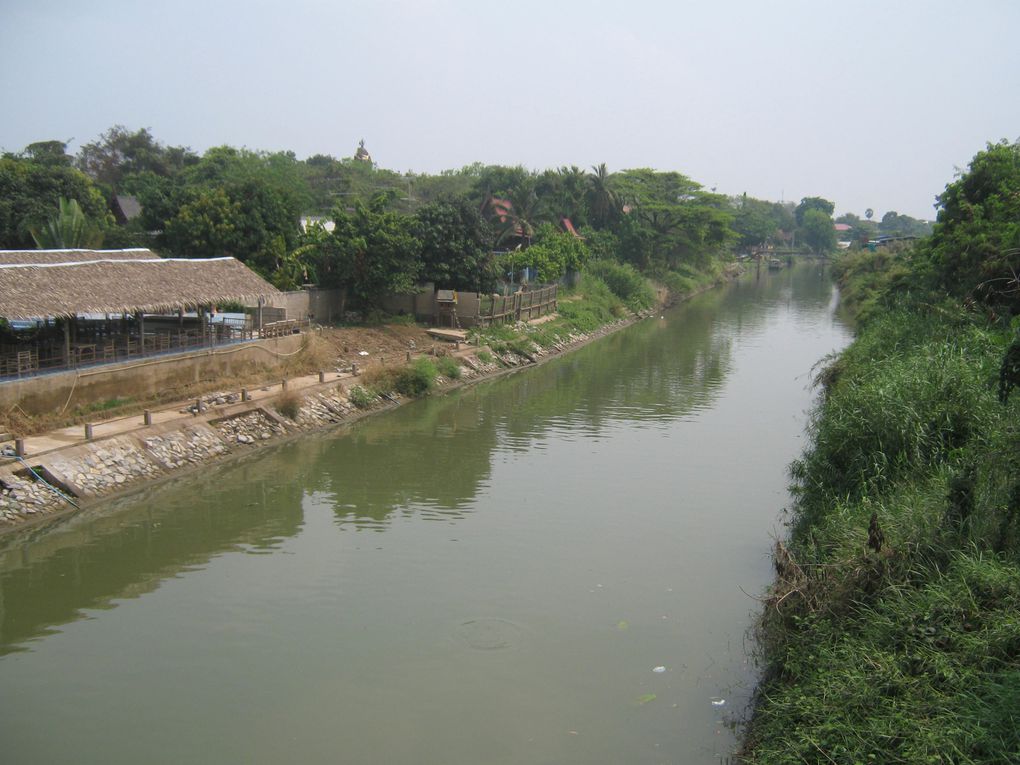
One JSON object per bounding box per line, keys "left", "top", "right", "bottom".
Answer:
{"left": 0, "top": 263, "right": 850, "bottom": 765}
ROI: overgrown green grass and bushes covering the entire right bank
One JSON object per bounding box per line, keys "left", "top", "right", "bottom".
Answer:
{"left": 743, "top": 143, "right": 1020, "bottom": 764}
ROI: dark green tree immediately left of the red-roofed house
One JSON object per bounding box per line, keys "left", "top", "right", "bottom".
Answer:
{"left": 414, "top": 197, "right": 496, "bottom": 292}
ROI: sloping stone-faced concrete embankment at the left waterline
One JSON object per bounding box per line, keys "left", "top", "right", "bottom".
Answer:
{"left": 0, "top": 318, "right": 635, "bottom": 532}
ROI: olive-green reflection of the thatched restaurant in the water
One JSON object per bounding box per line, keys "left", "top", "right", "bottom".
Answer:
{"left": 0, "top": 455, "right": 303, "bottom": 655}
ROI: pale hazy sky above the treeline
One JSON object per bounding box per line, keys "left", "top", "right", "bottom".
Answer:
{"left": 0, "top": 0, "right": 1020, "bottom": 217}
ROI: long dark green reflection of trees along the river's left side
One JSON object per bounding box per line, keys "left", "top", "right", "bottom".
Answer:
{"left": 0, "top": 266, "right": 831, "bottom": 654}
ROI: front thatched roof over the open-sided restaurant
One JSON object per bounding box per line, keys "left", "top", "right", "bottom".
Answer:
{"left": 0, "top": 256, "right": 278, "bottom": 319}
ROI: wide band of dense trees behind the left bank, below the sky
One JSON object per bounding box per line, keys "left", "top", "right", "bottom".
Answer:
{"left": 0, "top": 125, "right": 869, "bottom": 307}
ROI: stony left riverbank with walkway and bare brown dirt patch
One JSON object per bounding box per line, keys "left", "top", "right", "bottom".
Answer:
{"left": 0, "top": 317, "right": 640, "bottom": 533}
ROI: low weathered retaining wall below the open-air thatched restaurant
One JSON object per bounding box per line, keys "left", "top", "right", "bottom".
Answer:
{"left": 0, "top": 335, "right": 303, "bottom": 414}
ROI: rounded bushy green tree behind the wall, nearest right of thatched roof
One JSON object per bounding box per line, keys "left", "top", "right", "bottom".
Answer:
{"left": 316, "top": 194, "right": 420, "bottom": 307}
